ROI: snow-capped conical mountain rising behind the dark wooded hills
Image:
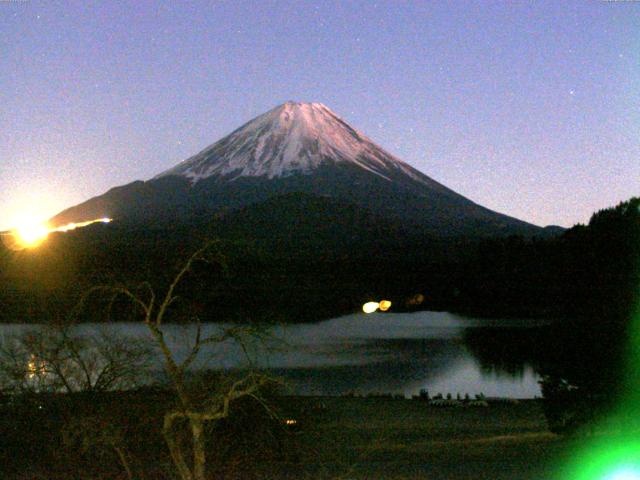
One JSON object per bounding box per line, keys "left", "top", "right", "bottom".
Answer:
{"left": 51, "top": 102, "right": 544, "bottom": 237}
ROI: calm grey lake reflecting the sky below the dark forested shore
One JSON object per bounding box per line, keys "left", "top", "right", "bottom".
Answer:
{"left": 0, "top": 312, "right": 542, "bottom": 398}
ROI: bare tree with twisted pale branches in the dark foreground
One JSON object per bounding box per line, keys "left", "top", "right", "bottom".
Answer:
{"left": 94, "top": 243, "right": 270, "bottom": 480}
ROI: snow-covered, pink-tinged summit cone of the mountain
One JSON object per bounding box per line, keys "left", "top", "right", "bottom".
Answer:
{"left": 155, "top": 102, "right": 428, "bottom": 183}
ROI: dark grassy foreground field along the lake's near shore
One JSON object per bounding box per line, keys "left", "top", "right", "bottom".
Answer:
{"left": 0, "top": 393, "right": 579, "bottom": 480}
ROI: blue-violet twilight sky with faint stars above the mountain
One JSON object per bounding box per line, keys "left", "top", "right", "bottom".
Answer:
{"left": 0, "top": 0, "right": 640, "bottom": 229}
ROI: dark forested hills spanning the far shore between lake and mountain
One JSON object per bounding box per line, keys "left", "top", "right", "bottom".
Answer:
{"left": 0, "top": 198, "right": 640, "bottom": 322}
